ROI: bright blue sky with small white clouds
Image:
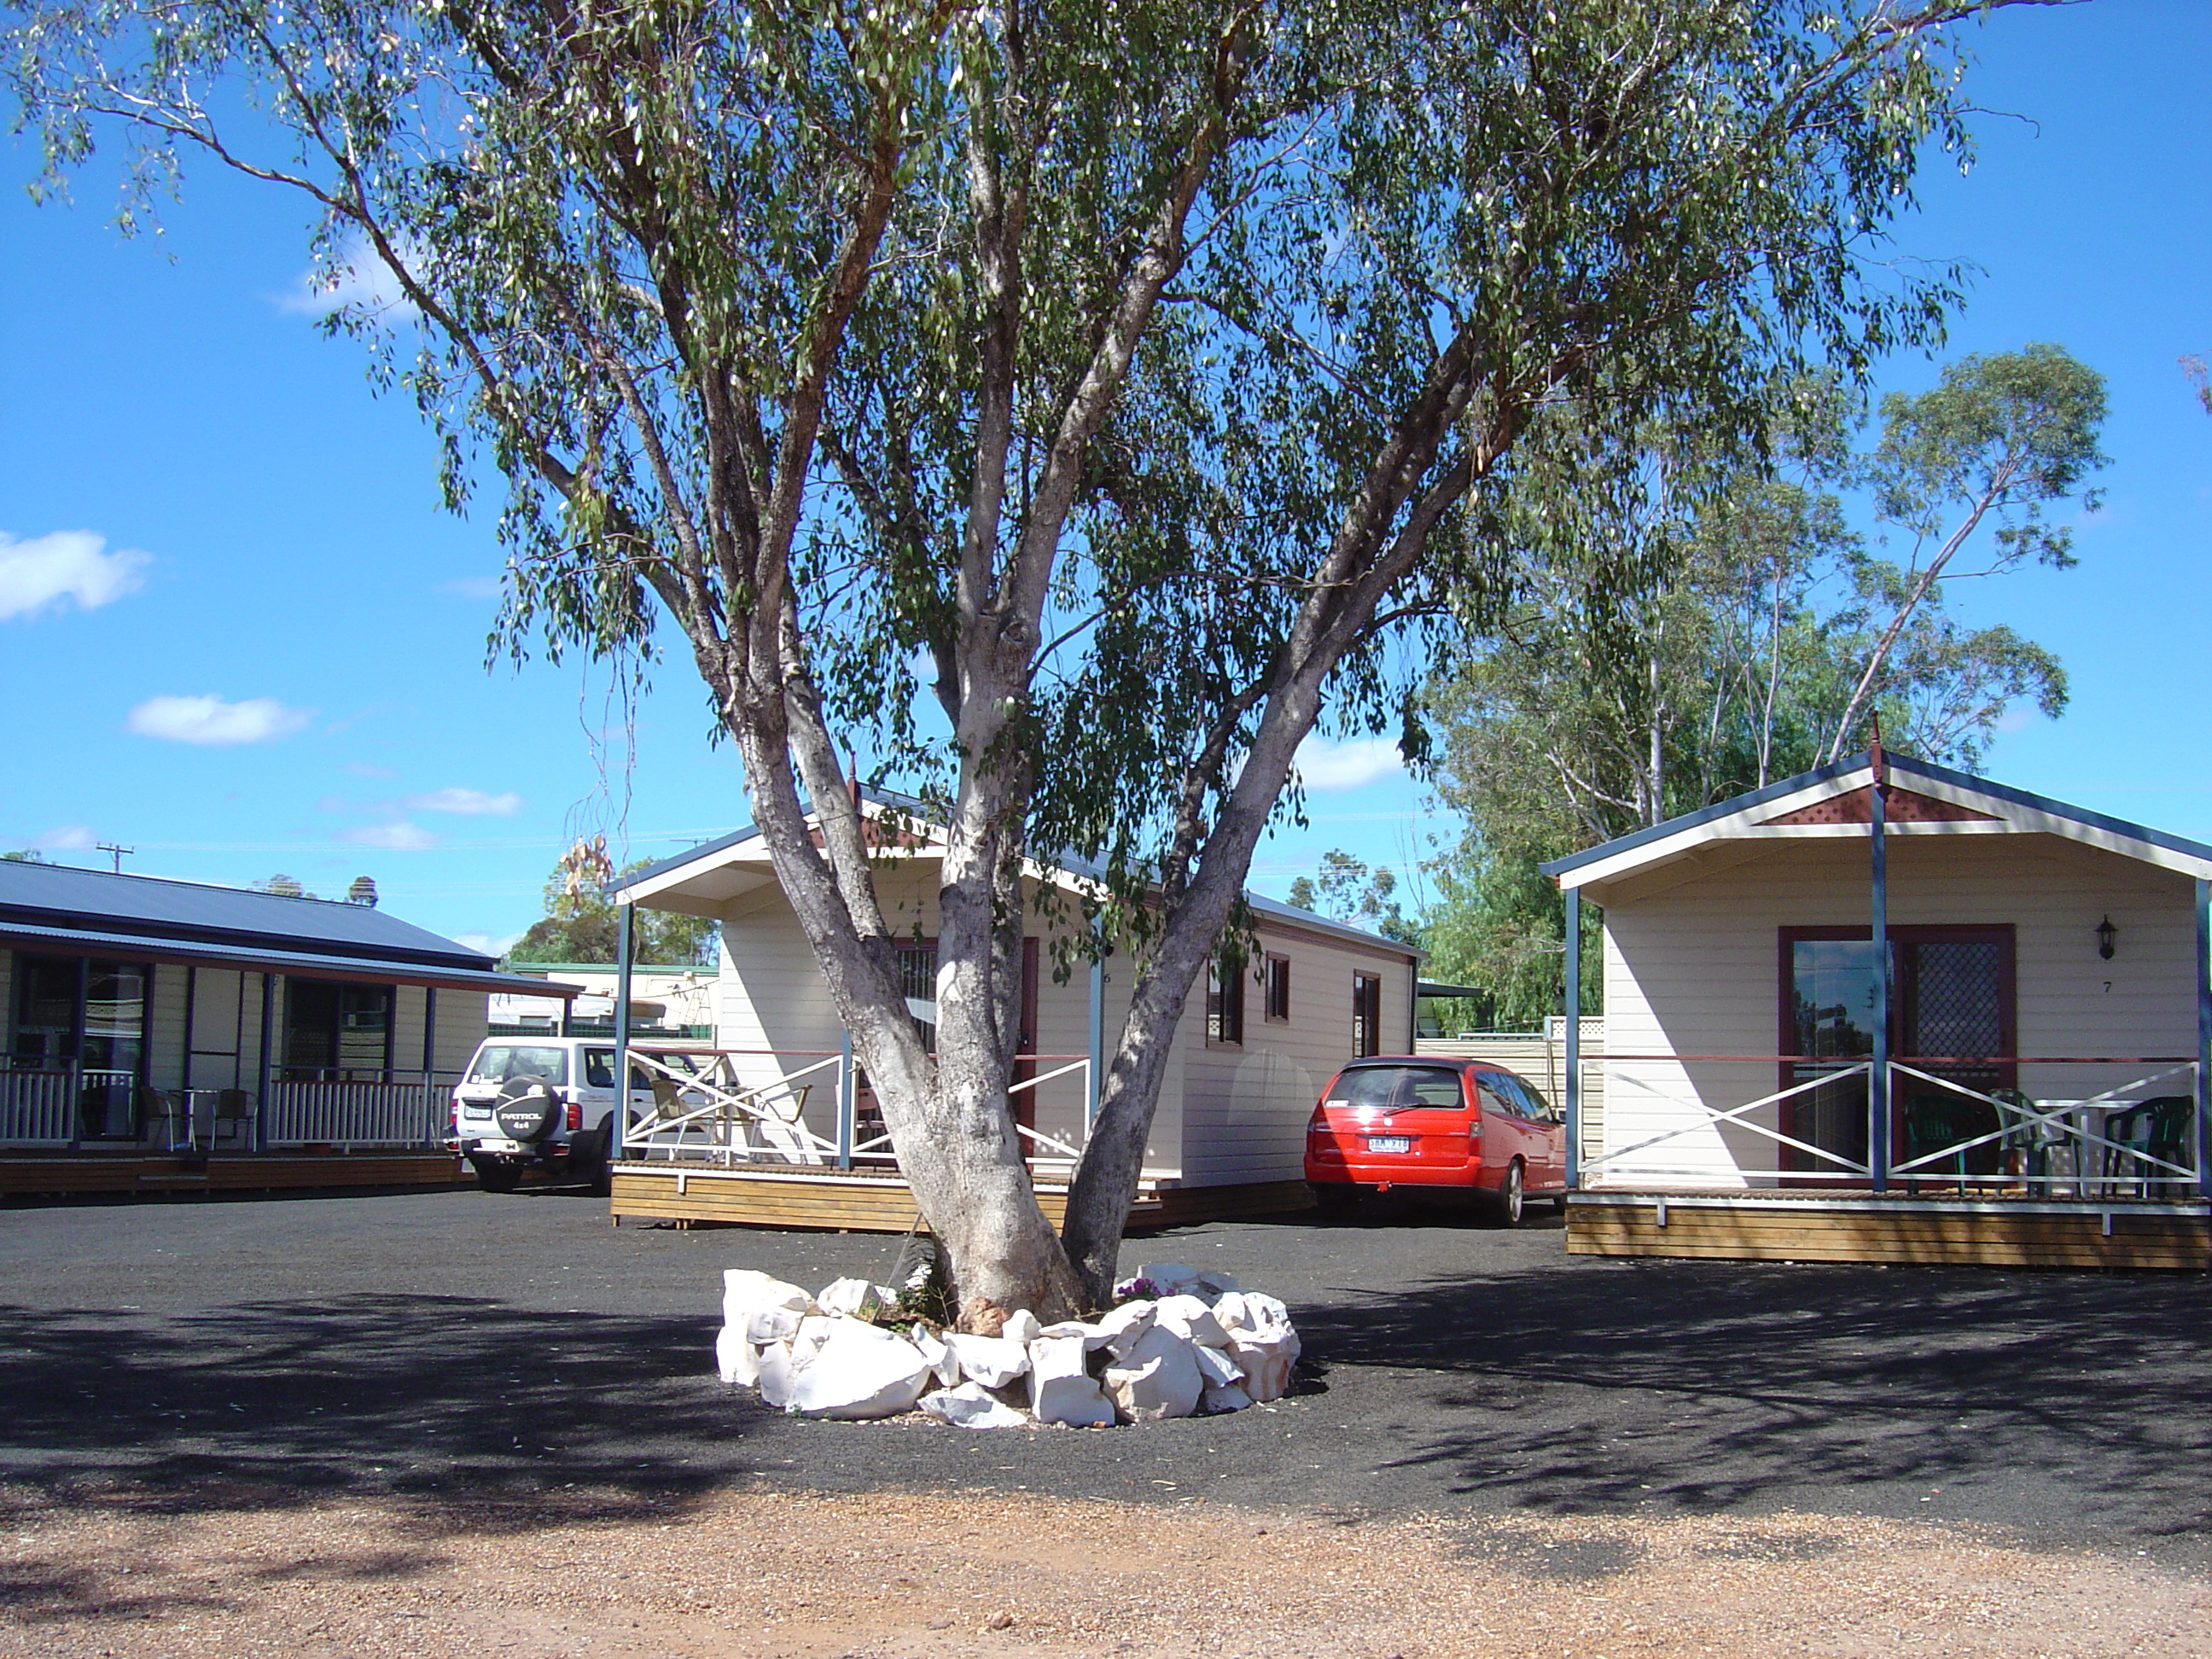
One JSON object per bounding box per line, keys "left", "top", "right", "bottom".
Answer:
{"left": 0, "top": 0, "right": 2212, "bottom": 942}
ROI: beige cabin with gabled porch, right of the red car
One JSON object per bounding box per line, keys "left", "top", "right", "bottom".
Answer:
{"left": 1546, "top": 752, "right": 2212, "bottom": 1220}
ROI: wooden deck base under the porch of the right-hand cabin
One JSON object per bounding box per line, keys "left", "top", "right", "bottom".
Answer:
{"left": 1566, "top": 1192, "right": 2212, "bottom": 1272}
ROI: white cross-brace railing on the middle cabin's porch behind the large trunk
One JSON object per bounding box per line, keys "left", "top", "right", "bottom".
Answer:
{"left": 624, "top": 1049, "right": 1091, "bottom": 1168}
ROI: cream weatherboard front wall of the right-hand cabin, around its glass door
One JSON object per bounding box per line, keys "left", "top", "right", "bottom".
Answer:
{"left": 1591, "top": 834, "right": 2197, "bottom": 1185}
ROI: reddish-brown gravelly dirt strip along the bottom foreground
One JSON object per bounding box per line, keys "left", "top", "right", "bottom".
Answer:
{"left": 0, "top": 1477, "right": 2212, "bottom": 1659}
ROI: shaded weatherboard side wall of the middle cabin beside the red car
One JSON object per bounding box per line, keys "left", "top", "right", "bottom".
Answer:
{"left": 1177, "top": 920, "right": 1416, "bottom": 1185}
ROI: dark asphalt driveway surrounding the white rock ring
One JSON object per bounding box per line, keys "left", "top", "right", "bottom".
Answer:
{"left": 0, "top": 1190, "right": 2212, "bottom": 1570}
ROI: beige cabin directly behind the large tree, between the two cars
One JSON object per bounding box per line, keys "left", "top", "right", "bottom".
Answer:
{"left": 615, "top": 792, "right": 1420, "bottom": 1208}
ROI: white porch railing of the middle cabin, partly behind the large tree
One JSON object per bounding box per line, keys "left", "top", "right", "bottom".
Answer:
{"left": 624, "top": 1049, "right": 1091, "bottom": 1174}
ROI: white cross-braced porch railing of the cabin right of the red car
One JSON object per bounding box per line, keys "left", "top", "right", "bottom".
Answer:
{"left": 1581, "top": 1055, "right": 2203, "bottom": 1199}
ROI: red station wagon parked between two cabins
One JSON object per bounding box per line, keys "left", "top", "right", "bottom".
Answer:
{"left": 1305, "top": 1055, "right": 1566, "bottom": 1228}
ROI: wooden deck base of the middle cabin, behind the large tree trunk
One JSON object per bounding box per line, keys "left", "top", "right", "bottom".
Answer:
{"left": 610, "top": 1161, "right": 1314, "bottom": 1232}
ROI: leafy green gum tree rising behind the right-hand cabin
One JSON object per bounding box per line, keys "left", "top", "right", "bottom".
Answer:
{"left": 1423, "top": 347, "right": 2104, "bottom": 1027}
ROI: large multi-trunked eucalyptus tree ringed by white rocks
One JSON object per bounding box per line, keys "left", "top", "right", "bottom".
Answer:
{"left": 9, "top": 0, "right": 2070, "bottom": 1330}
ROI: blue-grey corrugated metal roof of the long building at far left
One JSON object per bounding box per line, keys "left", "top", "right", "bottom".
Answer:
{"left": 0, "top": 859, "right": 498, "bottom": 971}
